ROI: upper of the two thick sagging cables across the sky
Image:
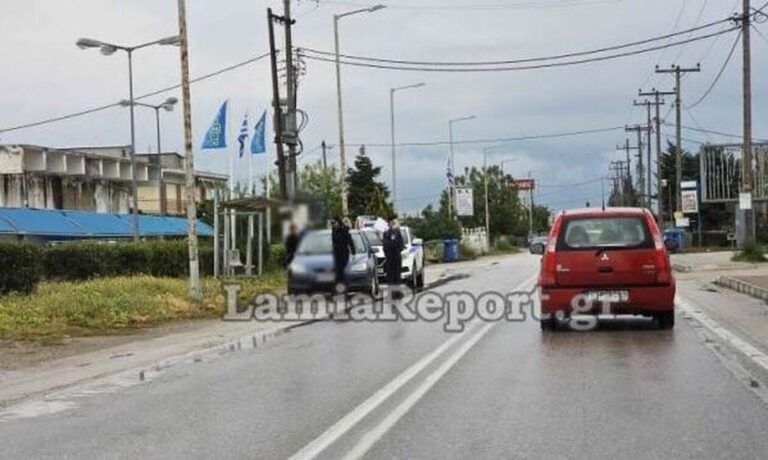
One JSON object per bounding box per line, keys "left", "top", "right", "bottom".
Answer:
{"left": 300, "top": 18, "right": 731, "bottom": 66}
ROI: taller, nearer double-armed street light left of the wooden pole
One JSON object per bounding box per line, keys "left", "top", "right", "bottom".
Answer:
{"left": 76, "top": 35, "right": 181, "bottom": 241}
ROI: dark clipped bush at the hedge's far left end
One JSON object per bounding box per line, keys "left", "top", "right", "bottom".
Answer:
{"left": 0, "top": 242, "right": 43, "bottom": 294}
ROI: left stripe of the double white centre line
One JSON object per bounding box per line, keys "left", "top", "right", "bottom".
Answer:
{"left": 289, "top": 276, "right": 536, "bottom": 460}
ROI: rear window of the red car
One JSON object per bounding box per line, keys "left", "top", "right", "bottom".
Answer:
{"left": 557, "top": 216, "right": 653, "bottom": 251}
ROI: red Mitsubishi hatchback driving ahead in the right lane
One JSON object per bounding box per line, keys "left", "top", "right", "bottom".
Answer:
{"left": 539, "top": 208, "right": 675, "bottom": 330}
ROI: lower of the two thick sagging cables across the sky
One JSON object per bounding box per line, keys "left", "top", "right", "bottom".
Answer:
{"left": 302, "top": 27, "right": 739, "bottom": 73}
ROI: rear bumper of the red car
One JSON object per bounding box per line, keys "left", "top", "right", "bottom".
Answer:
{"left": 539, "top": 284, "right": 675, "bottom": 315}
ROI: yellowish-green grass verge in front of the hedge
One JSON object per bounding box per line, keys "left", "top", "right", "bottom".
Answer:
{"left": 0, "top": 272, "right": 285, "bottom": 342}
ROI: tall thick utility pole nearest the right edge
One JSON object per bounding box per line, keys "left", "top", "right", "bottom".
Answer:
{"left": 737, "top": 0, "right": 755, "bottom": 248}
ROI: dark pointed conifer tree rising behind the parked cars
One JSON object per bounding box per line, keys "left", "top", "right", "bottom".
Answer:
{"left": 347, "top": 147, "right": 393, "bottom": 217}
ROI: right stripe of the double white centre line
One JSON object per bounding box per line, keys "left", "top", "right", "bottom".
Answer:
{"left": 344, "top": 323, "right": 497, "bottom": 460}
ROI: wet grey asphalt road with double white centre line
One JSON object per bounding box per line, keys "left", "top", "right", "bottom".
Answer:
{"left": 0, "top": 255, "right": 768, "bottom": 459}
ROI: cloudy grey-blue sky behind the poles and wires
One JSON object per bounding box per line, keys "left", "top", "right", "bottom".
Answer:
{"left": 0, "top": 0, "right": 768, "bottom": 211}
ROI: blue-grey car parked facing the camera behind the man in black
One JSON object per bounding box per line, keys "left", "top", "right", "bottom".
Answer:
{"left": 288, "top": 230, "right": 379, "bottom": 297}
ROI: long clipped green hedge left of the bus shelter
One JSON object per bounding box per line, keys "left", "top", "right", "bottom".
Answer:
{"left": 0, "top": 240, "right": 213, "bottom": 294}
